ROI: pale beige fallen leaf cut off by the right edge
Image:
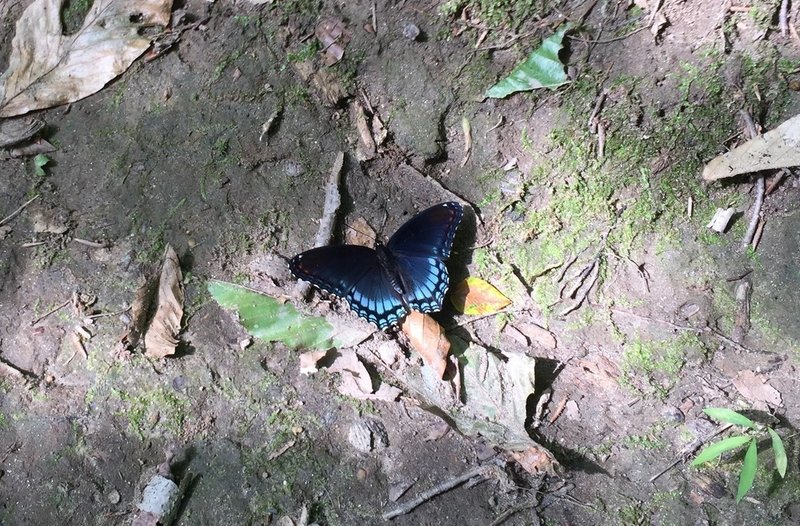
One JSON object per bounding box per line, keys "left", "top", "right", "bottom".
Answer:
{"left": 703, "top": 115, "right": 800, "bottom": 181}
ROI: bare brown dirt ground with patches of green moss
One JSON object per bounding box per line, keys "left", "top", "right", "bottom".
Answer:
{"left": 0, "top": 0, "right": 800, "bottom": 525}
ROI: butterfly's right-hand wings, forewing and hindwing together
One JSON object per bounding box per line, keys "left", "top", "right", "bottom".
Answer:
{"left": 386, "top": 202, "right": 464, "bottom": 312}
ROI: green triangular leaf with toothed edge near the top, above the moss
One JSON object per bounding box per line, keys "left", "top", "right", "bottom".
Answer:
{"left": 486, "top": 24, "right": 572, "bottom": 99}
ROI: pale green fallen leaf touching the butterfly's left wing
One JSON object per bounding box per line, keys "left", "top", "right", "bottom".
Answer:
{"left": 208, "top": 281, "right": 338, "bottom": 350}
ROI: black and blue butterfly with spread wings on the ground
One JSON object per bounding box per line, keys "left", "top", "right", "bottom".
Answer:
{"left": 289, "top": 202, "right": 464, "bottom": 329}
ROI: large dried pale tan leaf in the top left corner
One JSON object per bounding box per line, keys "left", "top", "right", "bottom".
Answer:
{"left": 0, "top": 0, "right": 172, "bottom": 117}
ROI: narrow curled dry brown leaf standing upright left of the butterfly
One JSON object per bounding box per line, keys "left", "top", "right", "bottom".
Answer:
{"left": 144, "top": 245, "right": 183, "bottom": 359}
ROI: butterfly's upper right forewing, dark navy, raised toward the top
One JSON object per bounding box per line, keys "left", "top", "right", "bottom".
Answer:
{"left": 386, "top": 202, "right": 464, "bottom": 260}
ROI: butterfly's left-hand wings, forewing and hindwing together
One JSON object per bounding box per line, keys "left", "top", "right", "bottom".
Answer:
{"left": 289, "top": 245, "right": 408, "bottom": 329}
